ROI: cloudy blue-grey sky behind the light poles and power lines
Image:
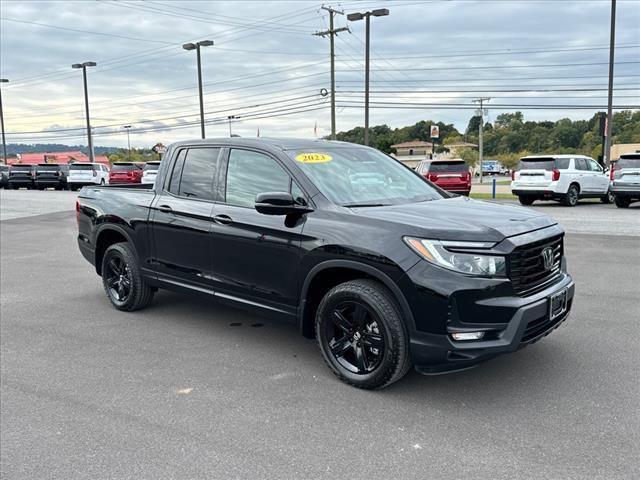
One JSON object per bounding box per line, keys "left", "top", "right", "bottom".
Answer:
{"left": 0, "top": 0, "right": 640, "bottom": 146}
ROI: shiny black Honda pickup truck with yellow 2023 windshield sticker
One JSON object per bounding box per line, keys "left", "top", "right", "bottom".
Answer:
{"left": 77, "top": 138, "right": 574, "bottom": 388}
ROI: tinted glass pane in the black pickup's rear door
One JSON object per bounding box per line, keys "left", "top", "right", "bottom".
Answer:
{"left": 178, "top": 148, "right": 220, "bottom": 200}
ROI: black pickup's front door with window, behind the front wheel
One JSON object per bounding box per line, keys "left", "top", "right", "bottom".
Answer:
{"left": 211, "top": 148, "right": 306, "bottom": 313}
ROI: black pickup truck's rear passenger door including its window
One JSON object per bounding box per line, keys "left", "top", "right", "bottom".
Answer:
{"left": 152, "top": 147, "right": 220, "bottom": 293}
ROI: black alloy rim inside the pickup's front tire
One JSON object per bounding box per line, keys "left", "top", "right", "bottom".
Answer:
{"left": 325, "top": 301, "right": 385, "bottom": 375}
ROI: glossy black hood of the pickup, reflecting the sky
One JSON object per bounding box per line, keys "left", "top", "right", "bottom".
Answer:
{"left": 353, "top": 197, "right": 557, "bottom": 242}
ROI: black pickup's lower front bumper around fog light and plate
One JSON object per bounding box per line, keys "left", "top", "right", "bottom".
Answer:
{"left": 410, "top": 273, "right": 575, "bottom": 374}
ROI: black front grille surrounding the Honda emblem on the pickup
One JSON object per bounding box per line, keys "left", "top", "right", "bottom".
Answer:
{"left": 509, "top": 235, "right": 563, "bottom": 296}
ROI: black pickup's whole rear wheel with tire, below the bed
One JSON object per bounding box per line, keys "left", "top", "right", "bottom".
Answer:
{"left": 102, "top": 242, "right": 154, "bottom": 312}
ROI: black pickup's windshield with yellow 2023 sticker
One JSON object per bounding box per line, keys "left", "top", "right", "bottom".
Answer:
{"left": 287, "top": 148, "right": 443, "bottom": 207}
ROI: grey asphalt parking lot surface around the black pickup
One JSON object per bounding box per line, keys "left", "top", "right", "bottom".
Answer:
{"left": 0, "top": 191, "right": 640, "bottom": 479}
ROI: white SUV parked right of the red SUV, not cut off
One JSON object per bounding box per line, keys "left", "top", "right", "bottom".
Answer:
{"left": 511, "top": 155, "right": 613, "bottom": 207}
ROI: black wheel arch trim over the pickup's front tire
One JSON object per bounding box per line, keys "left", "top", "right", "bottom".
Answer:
{"left": 298, "top": 260, "right": 415, "bottom": 338}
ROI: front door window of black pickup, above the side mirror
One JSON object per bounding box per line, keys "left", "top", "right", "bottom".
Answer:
{"left": 226, "top": 149, "right": 290, "bottom": 208}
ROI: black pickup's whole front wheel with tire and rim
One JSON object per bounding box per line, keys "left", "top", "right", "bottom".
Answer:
{"left": 315, "top": 279, "right": 411, "bottom": 389}
